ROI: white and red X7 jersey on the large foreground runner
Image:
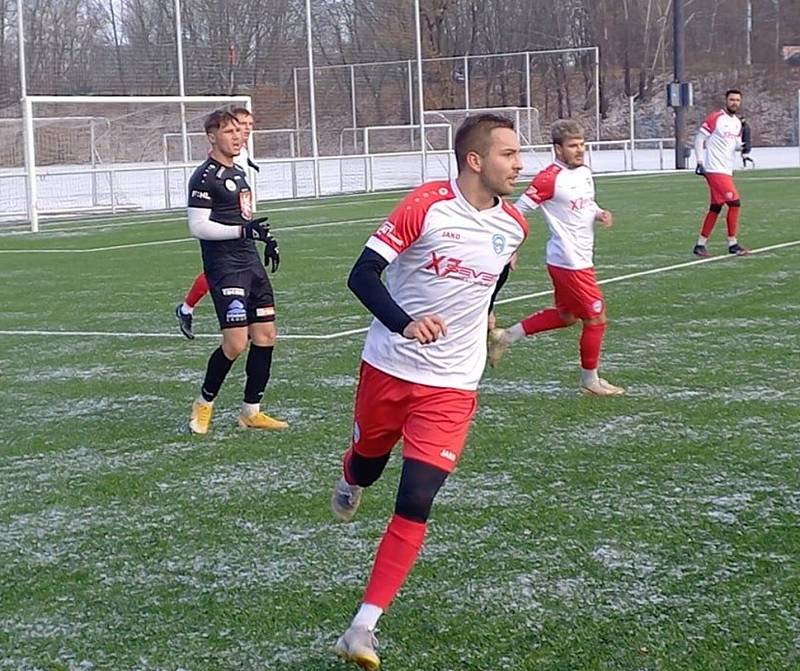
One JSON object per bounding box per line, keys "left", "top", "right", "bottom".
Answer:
{"left": 362, "top": 180, "right": 528, "bottom": 390}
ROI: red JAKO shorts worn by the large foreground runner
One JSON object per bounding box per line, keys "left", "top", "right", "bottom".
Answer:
{"left": 352, "top": 361, "right": 478, "bottom": 473}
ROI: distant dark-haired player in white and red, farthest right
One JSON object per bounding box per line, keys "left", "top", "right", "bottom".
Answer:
{"left": 692, "top": 89, "right": 750, "bottom": 258}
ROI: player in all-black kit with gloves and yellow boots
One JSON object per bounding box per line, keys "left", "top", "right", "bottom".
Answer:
{"left": 188, "top": 111, "right": 288, "bottom": 434}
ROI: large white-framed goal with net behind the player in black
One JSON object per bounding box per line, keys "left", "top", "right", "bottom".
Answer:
{"left": 20, "top": 96, "right": 255, "bottom": 232}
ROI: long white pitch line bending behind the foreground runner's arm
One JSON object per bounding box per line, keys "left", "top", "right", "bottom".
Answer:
{"left": 0, "top": 240, "right": 800, "bottom": 341}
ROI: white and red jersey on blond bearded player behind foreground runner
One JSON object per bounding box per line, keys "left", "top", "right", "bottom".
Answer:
{"left": 516, "top": 161, "right": 601, "bottom": 270}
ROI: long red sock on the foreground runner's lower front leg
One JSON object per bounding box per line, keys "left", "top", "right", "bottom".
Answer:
{"left": 364, "top": 515, "right": 428, "bottom": 610}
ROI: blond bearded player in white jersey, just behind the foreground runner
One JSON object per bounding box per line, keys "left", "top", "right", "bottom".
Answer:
{"left": 489, "top": 120, "right": 625, "bottom": 396}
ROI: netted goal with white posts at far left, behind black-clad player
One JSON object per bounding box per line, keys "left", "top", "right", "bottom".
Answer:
{"left": 6, "top": 96, "right": 251, "bottom": 230}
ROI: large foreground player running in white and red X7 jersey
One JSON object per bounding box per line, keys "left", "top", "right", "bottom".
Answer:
{"left": 331, "top": 114, "right": 528, "bottom": 669}
